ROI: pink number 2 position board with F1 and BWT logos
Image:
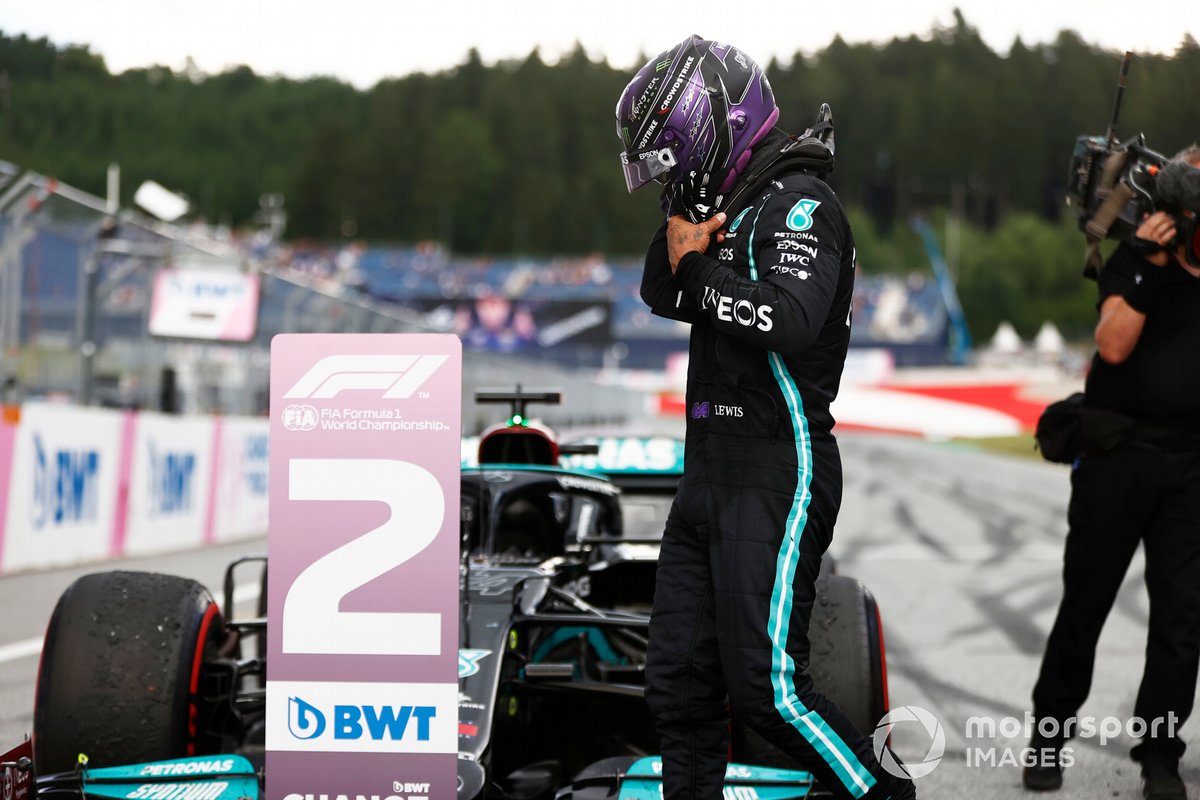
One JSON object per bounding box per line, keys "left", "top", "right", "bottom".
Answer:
{"left": 265, "top": 333, "right": 462, "bottom": 800}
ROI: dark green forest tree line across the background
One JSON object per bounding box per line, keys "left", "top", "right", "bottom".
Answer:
{"left": 0, "top": 13, "right": 1200, "bottom": 335}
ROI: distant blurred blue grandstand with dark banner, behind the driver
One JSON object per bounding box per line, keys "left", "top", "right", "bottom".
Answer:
{"left": 340, "top": 245, "right": 949, "bottom": 369}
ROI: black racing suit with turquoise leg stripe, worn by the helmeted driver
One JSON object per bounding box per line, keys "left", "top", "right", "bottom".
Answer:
{"left": 642, "top": 132, "right": 892, "bottom": 800}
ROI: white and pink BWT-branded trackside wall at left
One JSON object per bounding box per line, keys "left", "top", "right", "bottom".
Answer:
{"left": 0, "top": 403, "right": 268, "bottom": 575}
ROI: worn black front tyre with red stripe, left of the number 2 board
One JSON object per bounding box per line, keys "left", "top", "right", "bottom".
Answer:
{"left": 34, "top": 572, "right": 224, "bottom": 775}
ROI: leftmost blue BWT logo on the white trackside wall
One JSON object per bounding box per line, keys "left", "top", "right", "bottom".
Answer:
{"left": 30, "top": 433, "right": 100, "bottom": 529}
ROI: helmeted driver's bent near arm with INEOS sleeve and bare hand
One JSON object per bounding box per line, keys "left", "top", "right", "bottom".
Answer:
{"left": 667, "top": 181, "right": 845, "bottom": 355}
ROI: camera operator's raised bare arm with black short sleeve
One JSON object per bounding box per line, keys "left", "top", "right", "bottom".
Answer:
{"left": 1096, "top": 211, "right": 1175, "bottom": 365}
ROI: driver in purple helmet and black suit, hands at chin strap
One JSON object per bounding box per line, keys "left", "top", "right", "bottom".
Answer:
{"left": 617, "top": 36, "right": 916, "bottom": 800}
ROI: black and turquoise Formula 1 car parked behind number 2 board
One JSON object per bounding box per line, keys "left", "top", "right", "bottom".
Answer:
{"left": 11, "top": 387, "right": 887, "bottom": 800}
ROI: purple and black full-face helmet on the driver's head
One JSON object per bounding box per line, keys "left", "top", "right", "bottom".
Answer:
{"left": 617, "top": 36, "right": 779, "bottom": 222}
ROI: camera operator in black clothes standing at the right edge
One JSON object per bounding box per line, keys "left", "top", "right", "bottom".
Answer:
{"left": 1024, "top": 145, "right": 1200, "bottom": 800}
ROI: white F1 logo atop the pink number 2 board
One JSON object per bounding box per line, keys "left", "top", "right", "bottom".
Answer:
{"left": 283, "top": 355, "right": 449, "bottom": 399}
